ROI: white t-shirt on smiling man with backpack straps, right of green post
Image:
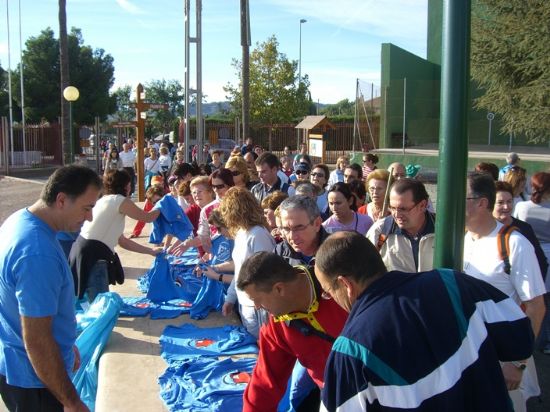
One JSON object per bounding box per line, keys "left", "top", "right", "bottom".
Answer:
{"left": 464, "top": 222, "right": 546, "bottom": 304}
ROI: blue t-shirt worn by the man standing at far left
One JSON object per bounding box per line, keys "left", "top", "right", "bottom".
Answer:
{"left": 0, "top": 209, "right": 76, "bottom": 388}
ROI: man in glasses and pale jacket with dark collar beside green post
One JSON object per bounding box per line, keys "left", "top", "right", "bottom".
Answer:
{"left": 367, "top": 178, "right": 435, "bottom": 273}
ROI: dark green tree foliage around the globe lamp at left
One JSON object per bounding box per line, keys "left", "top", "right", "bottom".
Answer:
{"left": 12, "top": 28, "right": 115, "bottom": 124}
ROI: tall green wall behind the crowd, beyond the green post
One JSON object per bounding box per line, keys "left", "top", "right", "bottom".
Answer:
{"left": 380, "top": 0, "right": 548, "bottom": 148}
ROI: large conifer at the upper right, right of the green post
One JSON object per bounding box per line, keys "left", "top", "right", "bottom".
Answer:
{"left": 471, "top": 0, "right": 550, "bottom": 142}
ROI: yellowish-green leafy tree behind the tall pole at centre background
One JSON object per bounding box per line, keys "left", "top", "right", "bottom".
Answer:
{"left": 224, "top": 36, "right": 310, "bottom": 124}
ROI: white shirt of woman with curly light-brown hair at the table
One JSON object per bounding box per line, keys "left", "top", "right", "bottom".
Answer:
{"left": 225, "top": 226, "right": 275, "bottom": 306}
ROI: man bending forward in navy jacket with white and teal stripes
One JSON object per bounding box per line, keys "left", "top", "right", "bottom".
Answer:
{"left": 315, "top": 232, "right": 533, "bottom": 412}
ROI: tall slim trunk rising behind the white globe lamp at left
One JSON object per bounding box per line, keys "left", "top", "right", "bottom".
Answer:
{"left": 59, "top": 0, "right": 73, "bottom": 165}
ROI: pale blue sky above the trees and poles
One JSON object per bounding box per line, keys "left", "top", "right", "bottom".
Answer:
{"left": 0, "top": 0, "right": 427, "bottom": 103}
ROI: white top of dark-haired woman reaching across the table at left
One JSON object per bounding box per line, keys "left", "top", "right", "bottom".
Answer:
{"left": 80, "top": 195, "right": 126, "bottom": 252}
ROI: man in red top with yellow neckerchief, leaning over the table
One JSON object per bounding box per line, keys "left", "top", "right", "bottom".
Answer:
{"left": 237, "top": 252, "right": 347, "bottom": 412}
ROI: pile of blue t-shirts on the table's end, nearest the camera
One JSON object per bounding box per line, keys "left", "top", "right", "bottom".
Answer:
{"left": 159, "top": 358, "right": 256, "bottom": 412}
